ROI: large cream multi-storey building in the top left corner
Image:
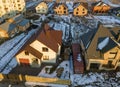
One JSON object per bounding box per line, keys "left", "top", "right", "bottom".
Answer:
{"left": 0, "top": 0, "right": 25, "bottom": 19}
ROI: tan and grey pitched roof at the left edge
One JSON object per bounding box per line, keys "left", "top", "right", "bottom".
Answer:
{"left": 0, "top": 22, "right": 16, "bottom": 32}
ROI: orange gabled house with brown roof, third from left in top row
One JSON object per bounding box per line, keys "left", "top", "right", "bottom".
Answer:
{"left": 73, "top": 3, "right": 88, "bottom": 16}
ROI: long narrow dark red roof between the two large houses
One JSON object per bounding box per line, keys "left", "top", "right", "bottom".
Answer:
{"left": 72, "top": 43, "right": 84, "bottom": 74}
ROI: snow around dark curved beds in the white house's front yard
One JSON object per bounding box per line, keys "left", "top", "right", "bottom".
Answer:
{"left": 38, "top": 61, "right": 69, "bottom": 79}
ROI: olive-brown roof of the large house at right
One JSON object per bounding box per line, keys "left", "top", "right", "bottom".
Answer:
{"left": 87, "top": 25, "right": 120, "bottom": 58}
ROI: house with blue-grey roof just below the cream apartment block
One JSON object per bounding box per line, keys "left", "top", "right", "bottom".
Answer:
{"left": 8, "top": 14, "right": 30, "bottom": 31}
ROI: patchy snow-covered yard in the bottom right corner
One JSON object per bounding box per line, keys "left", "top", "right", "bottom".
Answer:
{"left": 74, "top": 72, "right": 120, "bottom": 87}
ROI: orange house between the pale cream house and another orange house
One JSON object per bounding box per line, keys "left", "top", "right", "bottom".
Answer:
{"left": 54, "top": 4, "right": 68, "bottom": 15}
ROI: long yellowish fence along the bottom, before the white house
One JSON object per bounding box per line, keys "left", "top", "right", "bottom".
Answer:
{"left": 0, "top": 74, "right": 71, "bottom": 85}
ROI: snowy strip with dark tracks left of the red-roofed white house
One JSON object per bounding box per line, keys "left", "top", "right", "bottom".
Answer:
{"left": 0, "top": 29, "right": 36, "bottom": 74}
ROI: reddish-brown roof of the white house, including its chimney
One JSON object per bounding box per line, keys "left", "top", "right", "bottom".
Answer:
{"left": 16, "top": 24, "right": 62, "bottom": 58}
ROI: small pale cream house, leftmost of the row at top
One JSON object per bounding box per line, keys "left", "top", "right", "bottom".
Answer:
{"left": 35, "top": 2, "right": 48, "bottom": 14}
